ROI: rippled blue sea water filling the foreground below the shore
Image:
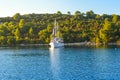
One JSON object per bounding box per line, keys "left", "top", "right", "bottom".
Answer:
{"left": 0, "top": 47, "right": 120, "bottom": 80}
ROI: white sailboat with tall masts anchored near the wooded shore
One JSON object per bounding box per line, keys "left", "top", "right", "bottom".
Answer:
{"left": 49, "top": 20, "right": 64, "bottom": 48}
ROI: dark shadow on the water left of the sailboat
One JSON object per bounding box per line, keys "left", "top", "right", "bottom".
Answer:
{"left": 3, "top": 46, "right": 48, "bottom": 57}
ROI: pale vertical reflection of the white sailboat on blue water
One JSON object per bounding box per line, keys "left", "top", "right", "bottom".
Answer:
{"left": 49, "top": 48, "right": 62, "bottom": 80}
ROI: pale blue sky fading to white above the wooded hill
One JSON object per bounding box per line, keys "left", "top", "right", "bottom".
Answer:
{"left": 0, "top": 0, "right": 120, "bottom": 17}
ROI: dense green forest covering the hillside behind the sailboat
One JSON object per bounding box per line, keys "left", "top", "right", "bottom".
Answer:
{"left": 0, "top": 10, "right": 120, "bottom": 45}
